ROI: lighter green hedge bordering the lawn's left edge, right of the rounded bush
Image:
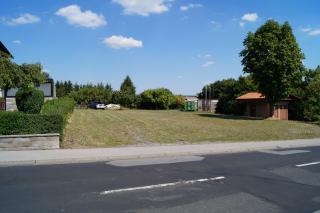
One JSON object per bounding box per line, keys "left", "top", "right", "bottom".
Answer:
{"left": 41, "top": 97, "right": 75, "bottom": 125}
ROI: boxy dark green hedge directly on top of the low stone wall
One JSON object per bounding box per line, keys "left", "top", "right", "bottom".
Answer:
{"left": 0, "top": 112, "right": 63, "bottom": 135}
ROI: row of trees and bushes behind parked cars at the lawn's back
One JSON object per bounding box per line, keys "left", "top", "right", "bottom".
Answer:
{"left": 56, "top": 76, "right": 184, "bottom": 109}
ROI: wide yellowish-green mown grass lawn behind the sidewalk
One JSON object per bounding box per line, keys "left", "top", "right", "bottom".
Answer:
{"left": 63, "top": 109, "right": 320, "bottom": 148}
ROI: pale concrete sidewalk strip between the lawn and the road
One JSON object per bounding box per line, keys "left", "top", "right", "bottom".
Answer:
{"left": 0, "top": 138, "right": 320, "bottom": 166}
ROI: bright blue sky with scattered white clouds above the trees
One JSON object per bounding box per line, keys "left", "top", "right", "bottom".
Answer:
{"left": 0, "top": 0, "right": 320, "bottom": 95}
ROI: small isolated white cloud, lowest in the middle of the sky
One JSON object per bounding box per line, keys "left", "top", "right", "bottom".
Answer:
{"left": 103, "top": 35, "right": 143, "bottom": 49}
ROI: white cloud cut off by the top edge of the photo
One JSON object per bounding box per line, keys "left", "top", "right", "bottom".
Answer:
{"left": 112, "top": 0, "right": 173, "bottom": 16}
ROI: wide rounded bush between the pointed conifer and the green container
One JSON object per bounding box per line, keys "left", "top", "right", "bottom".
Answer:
{"left": 139, "top": 88, "right": 175, "bottom": 109}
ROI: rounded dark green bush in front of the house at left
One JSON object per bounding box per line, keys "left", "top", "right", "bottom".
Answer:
{"left": 16, "top": 88, "right": 44, "bottom": 114}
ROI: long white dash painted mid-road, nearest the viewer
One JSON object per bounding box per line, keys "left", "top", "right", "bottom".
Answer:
{"left": 100, "top": 176, "right": 225, "bottom": 195}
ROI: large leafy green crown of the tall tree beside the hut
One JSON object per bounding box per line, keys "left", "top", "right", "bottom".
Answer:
{"left": 240, "top": 20, "right": 304, "bottom": 113}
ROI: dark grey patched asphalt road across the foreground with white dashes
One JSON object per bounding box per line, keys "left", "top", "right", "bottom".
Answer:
{"left": 0, "top": 147, "right": 320, "bottom": 213}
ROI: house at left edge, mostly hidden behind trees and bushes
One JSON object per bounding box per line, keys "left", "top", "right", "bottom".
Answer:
{"left": 0, "top": 41, "right": 56, "bottom": 111}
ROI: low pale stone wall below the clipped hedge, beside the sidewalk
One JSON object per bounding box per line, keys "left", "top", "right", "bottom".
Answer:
{"left": 0, "top": 134, "right": 60, "bottom": 151}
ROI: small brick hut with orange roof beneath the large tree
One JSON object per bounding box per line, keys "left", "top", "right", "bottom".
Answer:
{"left": 237, "top": 92, "right": 291, "bottom": 120}
